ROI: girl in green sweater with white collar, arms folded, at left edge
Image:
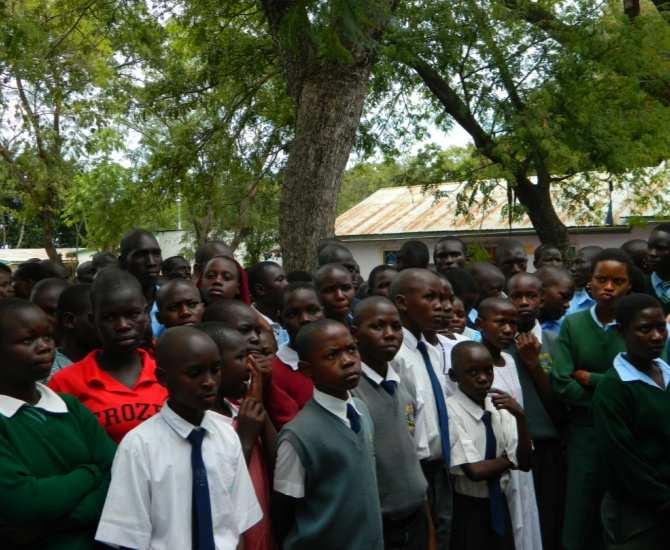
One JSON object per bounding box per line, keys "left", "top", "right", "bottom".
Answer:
{"left": 0, "top": 298, "right": 115, "bottom": 550}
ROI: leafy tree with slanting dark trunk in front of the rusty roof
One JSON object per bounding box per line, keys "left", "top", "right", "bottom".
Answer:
{"left": 388, "top": 0, "right": 670, "bottom": 247}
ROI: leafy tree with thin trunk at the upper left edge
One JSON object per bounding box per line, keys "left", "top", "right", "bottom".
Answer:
{"left": 0, "top": 0, "right": 139, "bottom": 260}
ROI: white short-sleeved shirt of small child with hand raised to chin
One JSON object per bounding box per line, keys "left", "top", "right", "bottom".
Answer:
{"left": 447, "top": 388, "right": 518, "bottom": 498}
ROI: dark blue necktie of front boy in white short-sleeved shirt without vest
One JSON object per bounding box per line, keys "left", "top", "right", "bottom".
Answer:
{"left": 188, "top": 428, "right": 215, "bottom": 550}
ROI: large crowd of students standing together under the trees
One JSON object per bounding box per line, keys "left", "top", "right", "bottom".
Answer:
{"left": 0, "top": 224, "right": 670, "bottom": 550}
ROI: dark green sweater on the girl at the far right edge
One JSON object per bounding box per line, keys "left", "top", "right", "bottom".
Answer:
{"left": 593, "top": 369, "right": 670, "bottom": 511}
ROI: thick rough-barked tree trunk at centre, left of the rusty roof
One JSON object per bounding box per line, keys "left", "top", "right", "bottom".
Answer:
{"left": 279, "top": 64, "right": 371, "bottom": 271}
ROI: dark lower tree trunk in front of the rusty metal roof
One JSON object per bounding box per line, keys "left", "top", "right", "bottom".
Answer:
{"left": 515, "top": 175, "right": 570, "bottom": 252}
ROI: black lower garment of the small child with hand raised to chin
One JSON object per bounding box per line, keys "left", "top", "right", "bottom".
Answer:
{"left": 451, "top": 493, "right": 514, "bottom": 550}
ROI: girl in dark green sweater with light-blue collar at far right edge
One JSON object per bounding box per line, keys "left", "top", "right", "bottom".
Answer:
{"left": 593, "top": 294, "right": 670, "bottom": 550}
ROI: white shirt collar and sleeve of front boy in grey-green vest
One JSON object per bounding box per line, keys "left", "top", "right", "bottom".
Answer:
{"left": 273, "top": 388, "right": 361, "bottom": 498}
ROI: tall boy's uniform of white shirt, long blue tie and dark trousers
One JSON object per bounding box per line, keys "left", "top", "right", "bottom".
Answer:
{"left": 390, "top": 327, "right": 452, "bottom": 548}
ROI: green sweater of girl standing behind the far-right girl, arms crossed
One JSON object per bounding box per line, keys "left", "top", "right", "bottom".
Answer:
{"left": 550, "top": 309, "right": 625, "bottom": 416}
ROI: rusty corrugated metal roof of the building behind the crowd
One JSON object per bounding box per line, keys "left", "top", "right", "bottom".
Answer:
{"left": 335, "top": 183, "right": 670, "bottom": 237}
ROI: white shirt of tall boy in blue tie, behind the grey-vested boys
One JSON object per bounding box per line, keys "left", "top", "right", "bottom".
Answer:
{"left": 391, "top": 327, "right": 445, "bottom": 460}
